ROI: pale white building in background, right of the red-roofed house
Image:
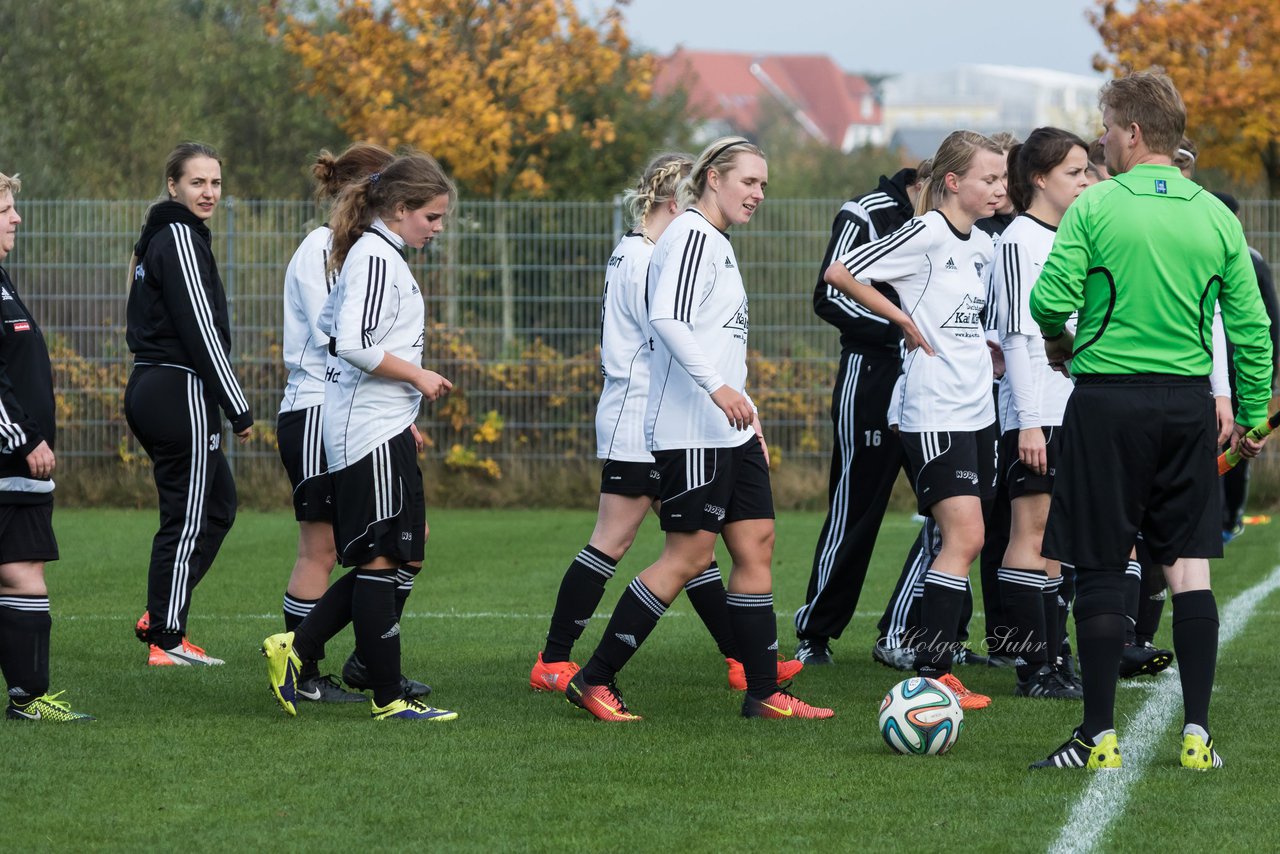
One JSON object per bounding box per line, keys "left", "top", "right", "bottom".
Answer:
{"left": 881, "top": 65, "right": 1105, "bottom": 159}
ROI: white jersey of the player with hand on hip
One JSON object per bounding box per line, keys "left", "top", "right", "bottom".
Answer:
{"left": 840, "top": 210, "right": 996, "bottom": 433}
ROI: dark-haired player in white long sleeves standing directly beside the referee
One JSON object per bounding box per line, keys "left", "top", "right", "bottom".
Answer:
{"left": 991, "top": 128, "right": 1089, "bottom": 699}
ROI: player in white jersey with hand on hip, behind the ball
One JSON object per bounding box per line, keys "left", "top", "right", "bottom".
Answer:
{"left": 826, "top": 131, "right": 1005, "bottom": 708}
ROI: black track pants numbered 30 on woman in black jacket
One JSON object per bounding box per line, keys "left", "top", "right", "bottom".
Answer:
{"left": 124, "top": 365, "right": 236, "bottom": 643}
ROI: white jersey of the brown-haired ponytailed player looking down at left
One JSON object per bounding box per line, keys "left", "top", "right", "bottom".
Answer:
{"left": 319, "top": 220, "right": 426, "bottom": 471}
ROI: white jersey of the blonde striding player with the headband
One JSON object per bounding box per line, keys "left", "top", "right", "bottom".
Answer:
{"left": 645, "top": 209, "right": 753, "bottom": 451}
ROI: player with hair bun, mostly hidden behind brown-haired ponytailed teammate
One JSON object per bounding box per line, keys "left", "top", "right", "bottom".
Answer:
{"left": 275, "top": 142, "right": 394, "bottom": 703}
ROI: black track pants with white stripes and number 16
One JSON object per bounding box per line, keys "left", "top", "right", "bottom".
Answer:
{"left": 796, "top": 351, "right": 902, "bottom": 640}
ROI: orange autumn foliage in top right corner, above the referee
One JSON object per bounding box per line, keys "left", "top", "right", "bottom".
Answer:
{"left": 1089, "top": 0, "right": 1280, "bottom": 198}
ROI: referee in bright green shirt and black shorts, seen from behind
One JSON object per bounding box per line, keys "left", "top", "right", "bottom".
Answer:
{"left": 1030, "top": 73, "right": 1271, "bottom": 769}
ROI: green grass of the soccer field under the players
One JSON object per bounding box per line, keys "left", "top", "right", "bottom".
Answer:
{"left": 0, "top": 510, "right": 1280, "bottom": 851}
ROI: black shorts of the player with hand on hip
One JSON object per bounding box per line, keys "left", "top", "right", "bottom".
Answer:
{"left": 899, "top": 421, "right": 1000, "bottom": 516}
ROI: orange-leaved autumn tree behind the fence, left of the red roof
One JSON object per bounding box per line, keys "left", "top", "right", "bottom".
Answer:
{"left": 270, "top": 0, "right": 654, "bottom": 344}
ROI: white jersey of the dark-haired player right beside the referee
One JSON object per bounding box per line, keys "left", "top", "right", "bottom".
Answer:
{"left": 991, "top": 214, "right": 1075, "bottom": 430}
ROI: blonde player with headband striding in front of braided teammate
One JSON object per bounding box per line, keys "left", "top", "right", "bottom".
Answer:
{"left": 564, "top": 137, "right": 833, "bottom": 721}
